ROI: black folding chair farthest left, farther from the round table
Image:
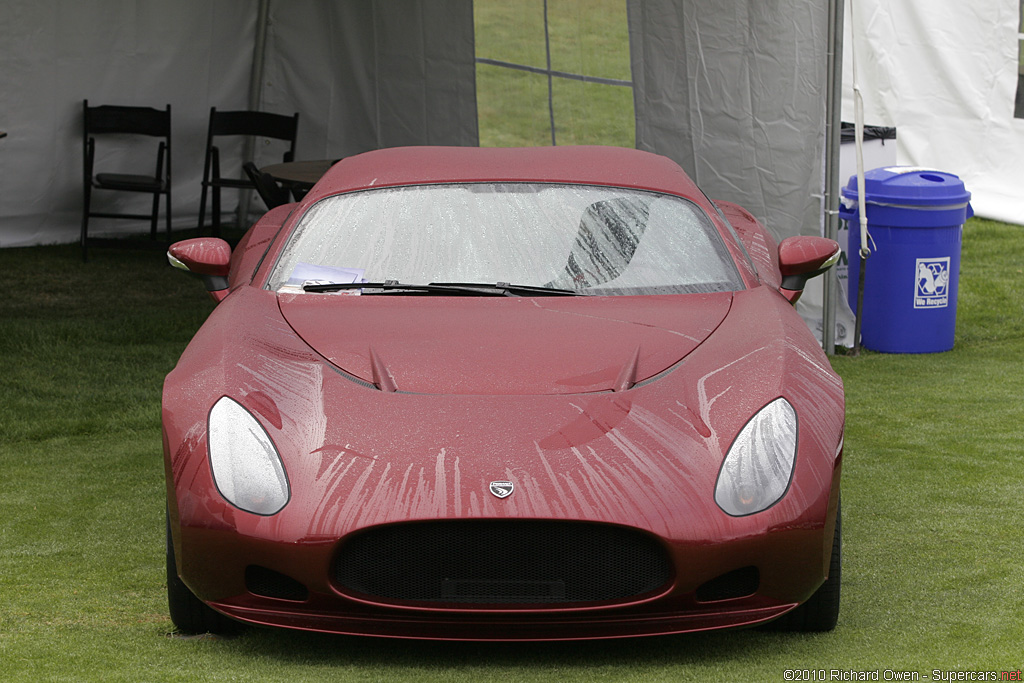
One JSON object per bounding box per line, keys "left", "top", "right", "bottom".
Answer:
{"left": 82, "top": 99, "right": 171, "bottom": 260}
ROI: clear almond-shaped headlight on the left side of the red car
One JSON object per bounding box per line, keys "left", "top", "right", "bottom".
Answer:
{"left": 208, "top": 396, "right": 289, "bottom": 515}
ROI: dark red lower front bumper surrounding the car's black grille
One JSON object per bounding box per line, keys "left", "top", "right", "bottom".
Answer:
{"left": 167, "top": 461, "right": 840, "bottom": 641}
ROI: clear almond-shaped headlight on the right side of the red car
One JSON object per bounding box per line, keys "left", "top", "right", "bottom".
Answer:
{"left": 715, "top": 398, "right": 797, "bottom": 517}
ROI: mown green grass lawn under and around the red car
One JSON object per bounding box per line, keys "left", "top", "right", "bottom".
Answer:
{"left": 0, "top": 219, "right": 1024, "bottom": 681}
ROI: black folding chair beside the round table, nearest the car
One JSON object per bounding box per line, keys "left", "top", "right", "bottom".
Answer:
{"left": 199, "top": 106, "right": 299, "bottom": 234}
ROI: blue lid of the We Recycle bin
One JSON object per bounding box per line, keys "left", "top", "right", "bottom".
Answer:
{"left": 843, "top": 166, "right": 971, "bottom": 207}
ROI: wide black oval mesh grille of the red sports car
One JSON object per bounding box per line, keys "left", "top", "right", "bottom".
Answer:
{"left": 333, "top": 519, "right": 672, "bottom": 604}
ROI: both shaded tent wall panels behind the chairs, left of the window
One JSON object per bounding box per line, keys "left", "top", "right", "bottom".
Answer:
{"left": 0, "top": 0, "right": 476, "bottom": 247}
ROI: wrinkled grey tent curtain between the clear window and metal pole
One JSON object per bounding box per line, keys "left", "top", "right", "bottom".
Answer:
{"left": 629, "top": 0, "right": 828, "bottom": 239}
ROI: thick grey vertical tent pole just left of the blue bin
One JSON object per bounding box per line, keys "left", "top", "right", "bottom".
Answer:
{"left": 821, "top": 0, "right": 849, "bottom": 355}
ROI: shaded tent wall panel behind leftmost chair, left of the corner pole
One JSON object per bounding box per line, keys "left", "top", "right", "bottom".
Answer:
{"left": 0, "top": 0, "right": 256, "bottom": 247}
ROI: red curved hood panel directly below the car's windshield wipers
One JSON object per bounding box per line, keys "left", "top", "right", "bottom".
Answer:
{"left": 279, "top": 292, "right": 732, "bottom": 395}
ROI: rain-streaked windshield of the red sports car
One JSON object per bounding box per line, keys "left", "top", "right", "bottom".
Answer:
{"left": 267, "top": 183, "right": 742, "bottom": 295}
